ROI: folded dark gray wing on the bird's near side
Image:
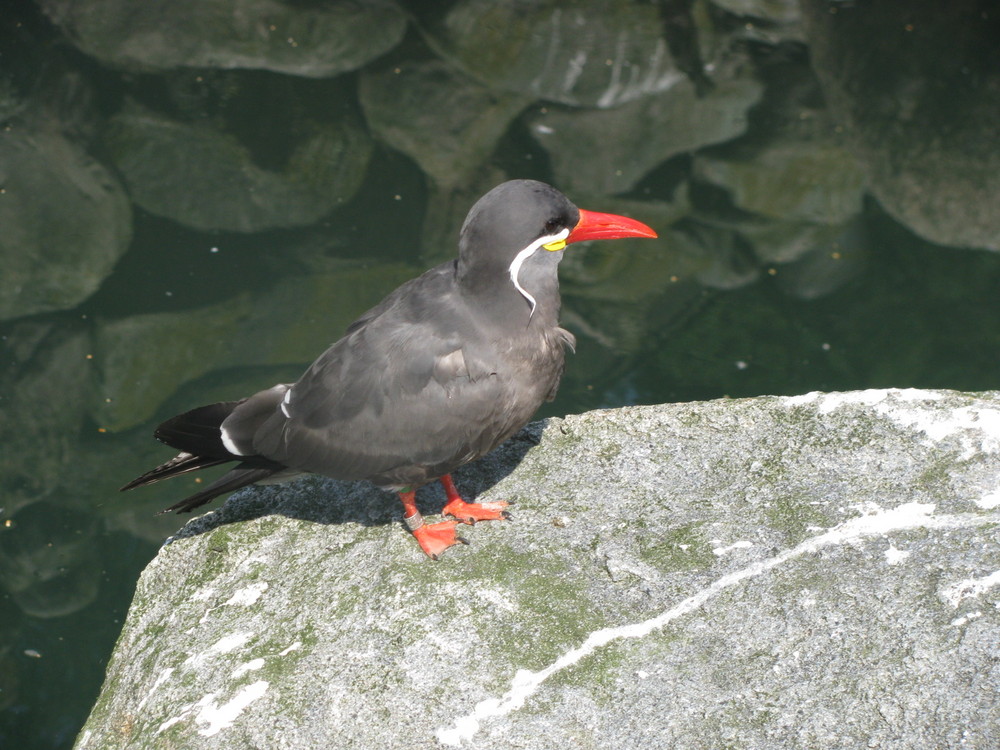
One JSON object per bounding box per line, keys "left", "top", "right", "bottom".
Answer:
{"left": 246, "top": 269, "right": 530, "bottom": 481}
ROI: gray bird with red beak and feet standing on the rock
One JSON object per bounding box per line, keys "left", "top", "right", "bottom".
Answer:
{"left": 121, "top": 180, "right": 657, "bottom": 560}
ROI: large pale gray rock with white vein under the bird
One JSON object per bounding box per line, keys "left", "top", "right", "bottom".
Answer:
{"left": 76, "top": 390, "right": 1000, "bottom": 750}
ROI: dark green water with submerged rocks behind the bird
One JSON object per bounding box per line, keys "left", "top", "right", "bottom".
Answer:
{"left": 0, "top": 0, "right": 1000, "bottom": 750}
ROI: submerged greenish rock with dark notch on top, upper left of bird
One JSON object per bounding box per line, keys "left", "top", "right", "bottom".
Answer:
{"left": 106, "top": 104, "right": 371, "bottom": 232}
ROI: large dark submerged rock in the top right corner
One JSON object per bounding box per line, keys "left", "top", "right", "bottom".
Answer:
{"left": 802, "top": 0, "right": 1000, "bottom": 250}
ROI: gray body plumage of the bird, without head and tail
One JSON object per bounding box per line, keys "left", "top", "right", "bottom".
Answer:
{"left": 238, "top": 251, "right": 573, "bottom": 487}
